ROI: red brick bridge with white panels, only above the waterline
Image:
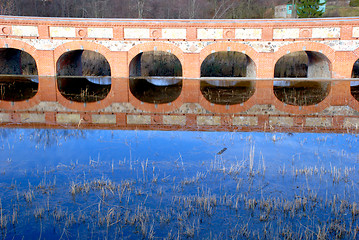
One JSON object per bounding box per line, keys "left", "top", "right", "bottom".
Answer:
{"left": 0, "top": 16, "right": 359, "bottom": 79}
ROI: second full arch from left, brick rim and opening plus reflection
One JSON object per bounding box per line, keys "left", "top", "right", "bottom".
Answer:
{"left": 128, "top": 42, "right": 184, "bottom": 111}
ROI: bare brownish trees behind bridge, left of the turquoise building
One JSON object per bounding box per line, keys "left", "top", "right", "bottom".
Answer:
{"left": 0, "top": 0, "right": 281, "bottom": 19}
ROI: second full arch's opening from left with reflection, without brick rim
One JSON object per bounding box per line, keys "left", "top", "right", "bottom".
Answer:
{"left": 129, "top": 51, "right": 182, "bottom": 104}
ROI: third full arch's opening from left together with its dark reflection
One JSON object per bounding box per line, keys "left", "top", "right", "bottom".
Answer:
{"left": 200, "top": 51, "right": 256, "bottom": 105}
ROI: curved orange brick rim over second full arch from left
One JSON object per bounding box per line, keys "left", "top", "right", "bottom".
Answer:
{"left": 127, "top": 42, "right": 184, "bottom": 67}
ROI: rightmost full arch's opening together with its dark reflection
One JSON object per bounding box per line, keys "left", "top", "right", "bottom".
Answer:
{"left": 273, "top": 51, "right": 331, "bottom": 106}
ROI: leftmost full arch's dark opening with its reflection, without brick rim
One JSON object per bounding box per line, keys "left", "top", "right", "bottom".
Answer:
{"left": 56, "top": 50, "right": 111, "bottom": 102}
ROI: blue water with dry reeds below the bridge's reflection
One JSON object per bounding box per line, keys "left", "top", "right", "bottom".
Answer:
{"left": 0, "top": 129, "right": 359, "bottom": 239}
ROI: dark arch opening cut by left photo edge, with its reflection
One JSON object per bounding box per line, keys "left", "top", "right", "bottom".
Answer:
{"left": 0, "top": 48, "right": 39, "bottom": 101}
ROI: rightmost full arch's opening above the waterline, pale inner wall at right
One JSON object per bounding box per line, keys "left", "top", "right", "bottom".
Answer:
{"left": 274, "top": 51, "right": 331, "bottom": 78}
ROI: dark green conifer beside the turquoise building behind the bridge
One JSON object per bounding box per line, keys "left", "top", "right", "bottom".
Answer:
{"left": 297, "top": 0, "right": 326, "bottom": 18}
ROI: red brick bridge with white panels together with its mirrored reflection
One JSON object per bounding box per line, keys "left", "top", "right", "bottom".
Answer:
{"left": 0, "top": 16, "right": 359, "bottom": 131}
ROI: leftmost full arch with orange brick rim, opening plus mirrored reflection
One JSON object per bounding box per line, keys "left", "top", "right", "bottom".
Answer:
{"left": 54, "top": 41, "right": 115, "bottom": 110}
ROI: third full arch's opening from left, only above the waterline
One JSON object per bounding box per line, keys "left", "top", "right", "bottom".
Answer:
{"left": 201, "top": 51, "right": 256, "bottom": 78}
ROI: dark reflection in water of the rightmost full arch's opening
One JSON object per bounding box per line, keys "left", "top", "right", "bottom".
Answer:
{"left": 273, "top": 81, "right": 330, "bottom": 106}
